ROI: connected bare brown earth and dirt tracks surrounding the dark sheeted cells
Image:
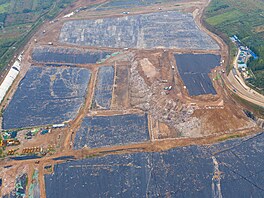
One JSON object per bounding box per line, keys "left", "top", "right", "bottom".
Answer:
{"left": 0, "top": 0, "right": 260, "bottom": 197}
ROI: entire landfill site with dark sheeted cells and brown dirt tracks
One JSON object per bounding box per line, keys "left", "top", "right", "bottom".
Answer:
{"left": 0, "top": 0, "right": 264, "bottom": 198}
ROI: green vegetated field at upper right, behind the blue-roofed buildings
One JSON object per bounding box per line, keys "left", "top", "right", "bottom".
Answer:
{"left": 204, "top": 0, "right": 264, "bottom": 93}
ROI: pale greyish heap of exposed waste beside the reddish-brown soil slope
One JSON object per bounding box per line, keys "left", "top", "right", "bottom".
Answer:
{"left": 129, "top": 55, "right": 201, "bottom": 137}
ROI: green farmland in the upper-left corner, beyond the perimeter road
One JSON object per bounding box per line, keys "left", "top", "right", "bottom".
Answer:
{"left": 0, "top": 0, "right": 74, "bottom": 71}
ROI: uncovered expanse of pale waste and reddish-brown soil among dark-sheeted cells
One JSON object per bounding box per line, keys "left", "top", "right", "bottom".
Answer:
{"left": 129, "top": 51, "right": 255, "bottom": 139}
